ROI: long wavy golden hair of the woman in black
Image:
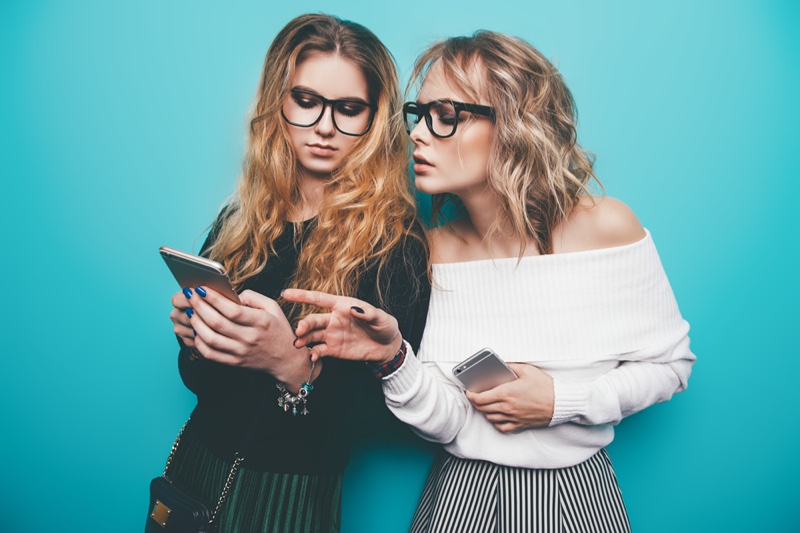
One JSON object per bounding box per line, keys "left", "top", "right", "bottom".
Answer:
{"left": 210, "top": 14, "right": 427, "bottom": 318}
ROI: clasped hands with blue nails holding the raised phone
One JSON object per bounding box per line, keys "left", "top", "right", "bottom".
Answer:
{"left": 170, "top": 287, "right": 320, "bottom": 390}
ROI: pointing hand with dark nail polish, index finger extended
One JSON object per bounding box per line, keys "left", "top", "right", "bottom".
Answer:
{"left": 282, "top": 289, "right": 403, "bottom": 363}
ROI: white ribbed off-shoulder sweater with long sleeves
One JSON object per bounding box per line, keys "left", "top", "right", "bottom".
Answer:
{"left": 383, "top": 232, "right": 695, "bottom": 468}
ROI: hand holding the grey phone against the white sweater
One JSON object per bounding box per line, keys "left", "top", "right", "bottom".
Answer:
{"left": 466, "top": 363, "right": 555, "bottom": 433}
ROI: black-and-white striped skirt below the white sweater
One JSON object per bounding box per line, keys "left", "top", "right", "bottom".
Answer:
{"left": 410, "top": 449, "right": 630, "bottom": 533}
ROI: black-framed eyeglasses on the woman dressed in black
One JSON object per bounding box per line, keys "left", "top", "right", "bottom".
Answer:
{"left": 281, "top": 89, "right": 378, "bottom": 137}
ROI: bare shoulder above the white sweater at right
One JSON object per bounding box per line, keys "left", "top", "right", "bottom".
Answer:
{"left": 553, "top": 196, "right": 645, "bottom": 253}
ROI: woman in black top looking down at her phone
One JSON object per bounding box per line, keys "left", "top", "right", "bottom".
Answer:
{"left": 159, "top": 15, "right": 430, "bottom": 532}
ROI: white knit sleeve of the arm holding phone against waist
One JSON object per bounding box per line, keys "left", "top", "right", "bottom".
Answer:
{"left": 550, "top": 322, "right": 696, "bottom": 426}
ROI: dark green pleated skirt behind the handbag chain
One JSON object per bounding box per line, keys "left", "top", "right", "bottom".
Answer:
{"left": 169, "top": 432, "right": 342, "bottom": 533}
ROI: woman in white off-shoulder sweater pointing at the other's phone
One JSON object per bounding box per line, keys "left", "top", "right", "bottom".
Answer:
{"left": 284, "top": 31, "right": 695, "bottom": 533}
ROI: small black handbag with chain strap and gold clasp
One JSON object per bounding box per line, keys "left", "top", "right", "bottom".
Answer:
{"left": 144, "top": 396, "right": 267, "bottom": 533}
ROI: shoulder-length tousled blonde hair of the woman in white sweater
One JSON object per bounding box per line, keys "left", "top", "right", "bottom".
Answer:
{"left": 408, "top": 30, "right": 602, "bottom": 256}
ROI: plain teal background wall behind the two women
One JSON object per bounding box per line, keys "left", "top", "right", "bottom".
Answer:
{"left": 0, "top": 0, "right": 800, "bottom": 532}
